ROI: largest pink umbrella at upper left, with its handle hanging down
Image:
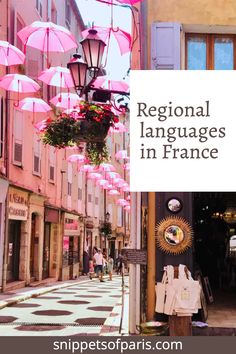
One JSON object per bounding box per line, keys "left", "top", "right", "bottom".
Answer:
{"left": 17, "top": 21, "right": 78, "bottom": 66}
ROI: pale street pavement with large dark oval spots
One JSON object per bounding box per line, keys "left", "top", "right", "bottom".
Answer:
{"left": 0, "top": 276, "right": 128, "bottom": 336}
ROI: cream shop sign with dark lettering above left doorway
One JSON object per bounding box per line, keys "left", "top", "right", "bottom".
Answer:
{"left": 8, "top": 188, "right": 28, "bottom": 220}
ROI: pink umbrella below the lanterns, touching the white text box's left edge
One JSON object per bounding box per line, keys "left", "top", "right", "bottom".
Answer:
{"left": 93, "top": 76, "right": 129, "bottom": 93}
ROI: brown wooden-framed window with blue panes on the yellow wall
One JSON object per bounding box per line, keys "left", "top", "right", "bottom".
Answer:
{"left": 186, "top": 34, "right": 236, "bottom": 70}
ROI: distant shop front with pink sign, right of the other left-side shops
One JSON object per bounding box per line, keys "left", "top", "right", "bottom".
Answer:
{"left": 62, "top": 213, "right": 83, "bottom": 280}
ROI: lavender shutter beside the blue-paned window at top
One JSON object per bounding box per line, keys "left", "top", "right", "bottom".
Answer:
{"left": 151, "top": 22, "right": 181, "bottom": 70}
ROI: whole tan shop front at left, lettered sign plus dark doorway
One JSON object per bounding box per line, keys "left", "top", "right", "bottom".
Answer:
{"left": 6, "top": 187, "right": 29, "bottom": 283}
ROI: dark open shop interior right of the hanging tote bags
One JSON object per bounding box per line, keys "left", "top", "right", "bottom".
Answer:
{"left": 193, "top": 192, "right": 236, "bottom": 327}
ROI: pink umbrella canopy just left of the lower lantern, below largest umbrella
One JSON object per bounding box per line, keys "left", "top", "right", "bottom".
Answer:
{"left": 39, "top": 66, "right": 74, "bottom": 88}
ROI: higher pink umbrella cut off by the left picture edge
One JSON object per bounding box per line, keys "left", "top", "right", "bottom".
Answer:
{"left": 0, "top": 41, "right": 25, "bottom": 66}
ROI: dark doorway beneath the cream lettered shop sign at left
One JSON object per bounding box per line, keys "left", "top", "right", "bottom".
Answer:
{"left": 7, "top": 220, "right": 21, "bottom": 282}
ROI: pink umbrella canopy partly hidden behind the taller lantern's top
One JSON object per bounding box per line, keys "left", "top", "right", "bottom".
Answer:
{"left": 82, "top": 26, "right": 131, "bottom": 55}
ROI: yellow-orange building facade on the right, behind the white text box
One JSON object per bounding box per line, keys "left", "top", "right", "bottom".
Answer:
{"left": 130, "top": 0, "right": 236, "bottom": 333}
